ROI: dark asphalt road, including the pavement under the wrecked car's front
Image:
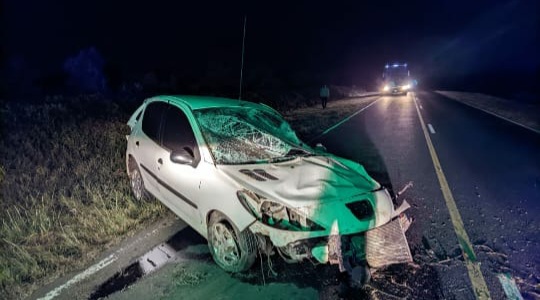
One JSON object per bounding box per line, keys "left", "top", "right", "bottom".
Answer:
{"left": 98, "top": 92, "right": 540, "bottom": 299}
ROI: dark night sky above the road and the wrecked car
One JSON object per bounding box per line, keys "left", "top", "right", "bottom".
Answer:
{"left": 2, "top": 0, "right": 540, "bottom": 90}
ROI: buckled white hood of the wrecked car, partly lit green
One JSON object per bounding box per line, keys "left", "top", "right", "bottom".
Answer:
{"left": 218, "top": 155, "right": 380, "bottom": 207}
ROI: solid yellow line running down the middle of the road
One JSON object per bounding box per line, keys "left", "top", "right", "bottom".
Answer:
{"left": 413, "top": 95, "right": 491, "bottom": 299}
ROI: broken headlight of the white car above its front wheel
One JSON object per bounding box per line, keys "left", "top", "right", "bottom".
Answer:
{"left": 236, "top": 190, "right": 324, "bottom": 231}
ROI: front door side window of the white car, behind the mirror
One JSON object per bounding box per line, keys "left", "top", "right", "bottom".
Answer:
{"left": 162, "top": 106, "right": 199, "bottom": 157}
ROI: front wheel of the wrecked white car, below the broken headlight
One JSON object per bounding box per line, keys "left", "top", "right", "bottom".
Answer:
{"left": 208, "top": 212, "right": 257, "bottom": 273}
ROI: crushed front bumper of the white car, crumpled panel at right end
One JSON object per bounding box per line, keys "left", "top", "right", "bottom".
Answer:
{"left": 250, "top": 201, "right": 412, "bottom": 271}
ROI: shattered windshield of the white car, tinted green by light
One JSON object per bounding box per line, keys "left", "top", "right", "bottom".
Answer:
{"left": 194, "top": 107, "right": 309, "bottom": 164}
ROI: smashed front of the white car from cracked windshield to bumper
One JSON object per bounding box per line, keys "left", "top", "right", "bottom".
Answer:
{"left": 194, "top": 107, "right": 412, "bottom": 282}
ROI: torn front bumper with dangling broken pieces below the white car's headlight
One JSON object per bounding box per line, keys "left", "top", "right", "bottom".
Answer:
{"left": 250, "top": 196, "right": 413, "bottom": 284}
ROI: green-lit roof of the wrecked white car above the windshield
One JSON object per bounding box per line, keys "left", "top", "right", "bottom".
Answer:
{"left": 149, "top": 95, "right": 275, "bottom": 112}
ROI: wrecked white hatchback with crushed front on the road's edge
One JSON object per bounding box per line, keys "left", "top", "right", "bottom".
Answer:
{"left": 126, "top": 96, "right": 412, "bottom": 282}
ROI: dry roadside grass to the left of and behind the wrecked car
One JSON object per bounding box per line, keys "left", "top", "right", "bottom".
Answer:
{"left": 0, "top": 92, "right": 373, "bottom": 299}
